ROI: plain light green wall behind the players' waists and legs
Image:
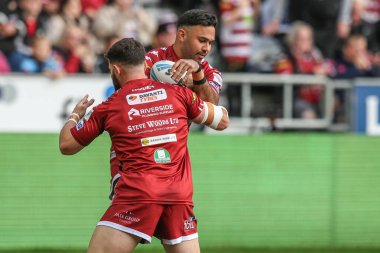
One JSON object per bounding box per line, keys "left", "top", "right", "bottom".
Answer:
{"left": 0, "top": 134, "right": 380, "bottom": 249}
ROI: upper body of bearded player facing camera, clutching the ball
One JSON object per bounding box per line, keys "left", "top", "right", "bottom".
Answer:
{"left": 145, "top": 9, "right": 222, "bottom": 104}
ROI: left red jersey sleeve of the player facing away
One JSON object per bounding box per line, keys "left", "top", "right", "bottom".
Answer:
{"left": 70, "top": 107, "right": 104, "bottom": 146}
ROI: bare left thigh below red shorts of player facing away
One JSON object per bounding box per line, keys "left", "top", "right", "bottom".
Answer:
{"left": 87, "top": 226, "right": 141, "bottom": 253}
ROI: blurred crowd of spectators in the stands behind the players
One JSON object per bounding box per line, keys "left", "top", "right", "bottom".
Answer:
{"left": 0, "top": 0, "right": 380, "bottom": 118}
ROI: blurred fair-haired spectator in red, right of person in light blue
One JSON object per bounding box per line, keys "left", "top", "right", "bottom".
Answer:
{"left": 58, "top": 26, "right": 95, "bottom": 74}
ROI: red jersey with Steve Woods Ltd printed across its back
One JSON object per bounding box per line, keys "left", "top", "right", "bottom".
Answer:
{"left": 71, "top": 79, "right": 203, "bottom": 205}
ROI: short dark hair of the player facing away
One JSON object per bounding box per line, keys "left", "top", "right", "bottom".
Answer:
{"left": 104, "top": 38, "right": 145, "bottom": 66}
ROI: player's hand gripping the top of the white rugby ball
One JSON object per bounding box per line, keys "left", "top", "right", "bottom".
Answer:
{"left": 170, "top": 59, "right": 199, "bottom": 86}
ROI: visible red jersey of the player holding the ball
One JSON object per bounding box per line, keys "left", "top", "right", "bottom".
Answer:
{"left": 145, "top": 46, "right": 223, "bottom": 94}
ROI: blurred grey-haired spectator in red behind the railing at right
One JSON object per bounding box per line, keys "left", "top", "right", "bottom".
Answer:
{"left": 275, "top": 21, "right": 327, "bottom": 119}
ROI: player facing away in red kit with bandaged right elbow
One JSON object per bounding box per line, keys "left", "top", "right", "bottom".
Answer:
{"left": 59, "top": 38, "right": 229, "bottom": 253}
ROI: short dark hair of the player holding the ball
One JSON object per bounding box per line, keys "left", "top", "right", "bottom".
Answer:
{"left": 177, "top": 9, "right": 218, "bottom": 28}
